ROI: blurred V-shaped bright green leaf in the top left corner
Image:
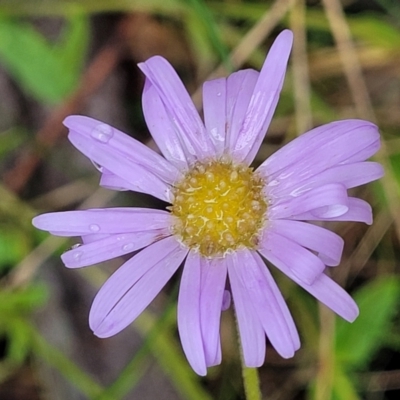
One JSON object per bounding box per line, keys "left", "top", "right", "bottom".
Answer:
{"left": 0, "top": 16, "right": 89, "bottom": 103}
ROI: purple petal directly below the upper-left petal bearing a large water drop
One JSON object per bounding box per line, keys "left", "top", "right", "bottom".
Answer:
{"left": 68, "top": 130, "right": 170, "bottom": 201}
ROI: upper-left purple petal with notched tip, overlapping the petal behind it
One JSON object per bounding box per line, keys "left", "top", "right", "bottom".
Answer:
{"left": 138, "top": 56, "right": 214, "bottom": 157}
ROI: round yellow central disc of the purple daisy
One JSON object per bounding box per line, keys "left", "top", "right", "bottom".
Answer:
{"left": 170, "top": 160, "right": 267, "bottom": 257}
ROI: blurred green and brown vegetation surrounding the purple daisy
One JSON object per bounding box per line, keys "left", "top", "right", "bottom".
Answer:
{"left": 0, "top": 0, "right": 400, "bottom": 400}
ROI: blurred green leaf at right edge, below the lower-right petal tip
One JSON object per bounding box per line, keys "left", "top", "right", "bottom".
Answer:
{"left": 336, "top": 277, "right": 400, "bottom": 368}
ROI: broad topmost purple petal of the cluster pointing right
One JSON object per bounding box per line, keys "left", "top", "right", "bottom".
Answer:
{"left": 257, "top": 120, "right": 379, "bottom": 196}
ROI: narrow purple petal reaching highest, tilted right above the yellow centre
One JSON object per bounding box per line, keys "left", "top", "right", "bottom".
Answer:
{"left": 233, "top": 30, "right": 293, "bottom": 164}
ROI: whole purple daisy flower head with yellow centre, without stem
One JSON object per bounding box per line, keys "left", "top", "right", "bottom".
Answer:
{"left": 33, "top": 30, "right": 383, "bottom": 375}
